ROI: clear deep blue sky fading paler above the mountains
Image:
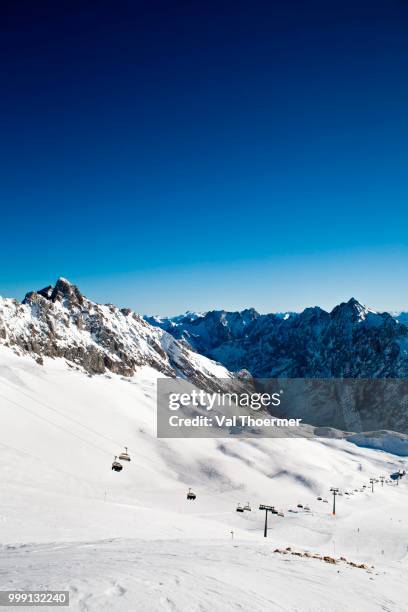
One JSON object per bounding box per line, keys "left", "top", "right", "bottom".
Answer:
{"left": 0, "top": 0, "right": 408, "bottom": 314}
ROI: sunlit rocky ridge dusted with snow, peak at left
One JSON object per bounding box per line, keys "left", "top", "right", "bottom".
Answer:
{"left": 0, "top": 278, "right": 230, "bottom": 385}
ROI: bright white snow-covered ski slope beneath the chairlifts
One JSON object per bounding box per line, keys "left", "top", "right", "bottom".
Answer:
{"left": 0, "top": 348, "right": 408, "bottom": 612}
